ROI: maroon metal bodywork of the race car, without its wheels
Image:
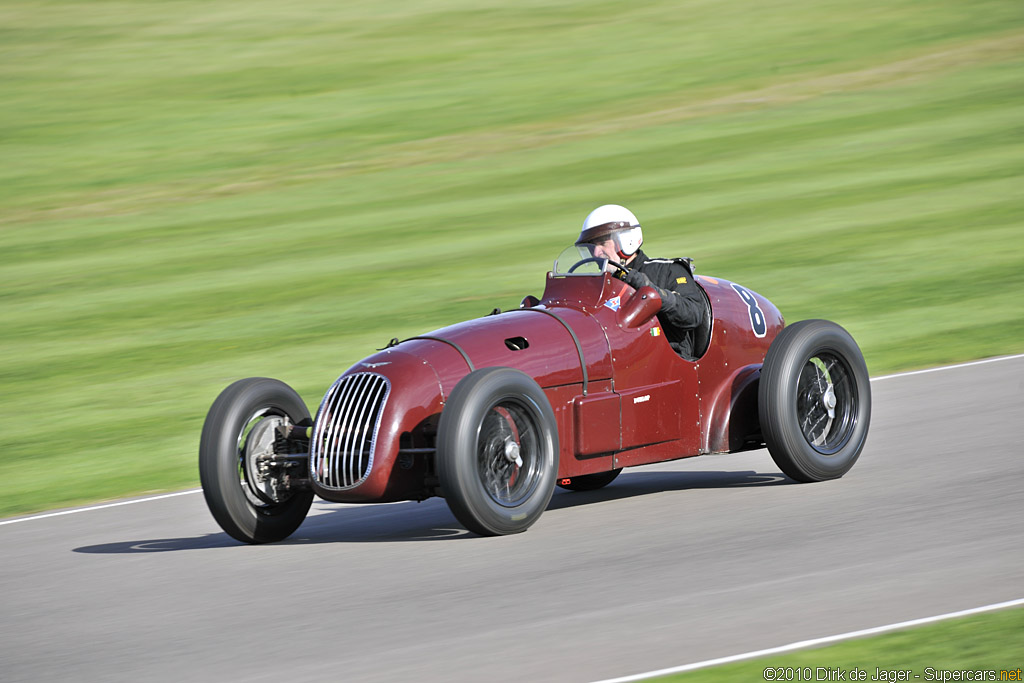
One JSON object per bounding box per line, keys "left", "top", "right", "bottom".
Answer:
{"left": 311, "top": 262, "right": 783, "bottom": 503}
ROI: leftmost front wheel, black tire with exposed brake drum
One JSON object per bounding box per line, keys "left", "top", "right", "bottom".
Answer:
{"left": 199, "top": 377, "right": 313, "bottom": 543}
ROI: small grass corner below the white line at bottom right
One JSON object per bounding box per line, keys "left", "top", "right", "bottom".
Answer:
{"left": 651, "top": 608, "right": 1024, "bottom": 683}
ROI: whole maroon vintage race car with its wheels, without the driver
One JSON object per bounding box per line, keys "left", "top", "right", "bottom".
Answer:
{"left": 200, "top": 245, "right": 871, "bottom": 543}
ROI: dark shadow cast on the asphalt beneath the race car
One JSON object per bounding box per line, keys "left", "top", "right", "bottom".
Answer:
{"left": 74, "top": 470, "right": 793, "bottom": 555}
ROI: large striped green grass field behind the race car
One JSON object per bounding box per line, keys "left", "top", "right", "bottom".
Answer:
{"left": 0, "top": 0, "right": 1024, "bottom": 516}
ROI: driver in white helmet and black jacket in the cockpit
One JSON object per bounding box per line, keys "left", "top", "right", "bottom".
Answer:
{"left": 577, "top": 204, "right": 708, "bottom": 360}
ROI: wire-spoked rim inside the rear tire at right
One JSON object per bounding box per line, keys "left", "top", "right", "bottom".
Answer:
{"left": 797, "top": 352, "right": 857, "bottom": 456}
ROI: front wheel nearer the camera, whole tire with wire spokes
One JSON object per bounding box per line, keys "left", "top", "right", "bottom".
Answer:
{"left": 437, "top": 368, "right": 558, "bottom": 536}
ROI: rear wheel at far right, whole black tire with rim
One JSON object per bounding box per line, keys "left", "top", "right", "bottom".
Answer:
{"left": 758, "top": 321, "right": 871, "bottom": 482}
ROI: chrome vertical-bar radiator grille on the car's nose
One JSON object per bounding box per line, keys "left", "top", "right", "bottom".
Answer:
{"left": 309, "top": 373, "right": 391, "bottom": 490}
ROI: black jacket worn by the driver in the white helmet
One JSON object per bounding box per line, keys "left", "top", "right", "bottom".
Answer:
{"left": 620, "top": 251, "right": 708, "bottom": 360}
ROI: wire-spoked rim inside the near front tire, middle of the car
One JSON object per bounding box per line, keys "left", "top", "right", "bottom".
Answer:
{"left": 476, "top": 399, "right": 544, "bottom": 508}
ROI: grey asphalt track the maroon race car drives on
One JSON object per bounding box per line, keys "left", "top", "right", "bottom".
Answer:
{"left": 0, "top": 356, "right": 1024, "bottom": 682}
